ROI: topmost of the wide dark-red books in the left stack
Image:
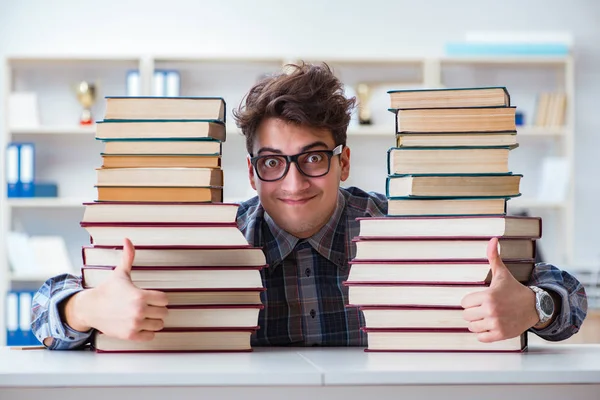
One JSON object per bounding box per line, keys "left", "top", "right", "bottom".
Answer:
{"left": 81, "top": 202, "right": 239, "bottom": 223}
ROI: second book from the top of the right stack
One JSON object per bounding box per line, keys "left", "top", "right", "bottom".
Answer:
{"left": 396, "top": 107, "right": 516, "bottom": 133}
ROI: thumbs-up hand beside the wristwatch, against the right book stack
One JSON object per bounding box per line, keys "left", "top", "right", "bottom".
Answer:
{"left": 461, "top": 238, "right": 539, "bottom": 342}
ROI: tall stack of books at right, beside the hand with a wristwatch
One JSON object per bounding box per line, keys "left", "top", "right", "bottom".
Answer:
{"left": 345, "top": 87, "right": 541, "bottom": 351}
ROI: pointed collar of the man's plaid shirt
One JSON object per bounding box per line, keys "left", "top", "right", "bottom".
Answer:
{"left": 264, "top": 191, "right": 346, "bottom": 267}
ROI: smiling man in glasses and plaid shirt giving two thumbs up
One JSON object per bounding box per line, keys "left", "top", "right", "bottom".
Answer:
{"left": 32, "top": 64, "right": 587, "bottom": 349}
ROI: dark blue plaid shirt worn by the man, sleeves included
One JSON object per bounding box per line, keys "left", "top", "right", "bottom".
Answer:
{"left": 32, "top": 188, "right": 587, "bottom": 350}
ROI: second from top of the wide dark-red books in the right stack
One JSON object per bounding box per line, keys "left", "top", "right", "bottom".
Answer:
{"left": 353, "top": 236, "right": 536, "bottom": 260}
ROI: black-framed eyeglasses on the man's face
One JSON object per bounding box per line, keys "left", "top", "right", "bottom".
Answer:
{"left": 250, "top": 144, "right": 344, "bottom": 182}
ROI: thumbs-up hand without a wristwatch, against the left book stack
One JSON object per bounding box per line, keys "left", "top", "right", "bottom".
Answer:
{"left": 64, "top": 239, "right": 168, "bottom": 341}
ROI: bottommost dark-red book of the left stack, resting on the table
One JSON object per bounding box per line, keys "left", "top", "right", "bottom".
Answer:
{"left": 92, "top": 327, "right": 255, "bottom": 353}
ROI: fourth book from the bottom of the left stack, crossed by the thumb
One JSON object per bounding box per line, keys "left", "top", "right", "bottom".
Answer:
{"left": 81, "top": 266, "right": 262, "bottom": 290}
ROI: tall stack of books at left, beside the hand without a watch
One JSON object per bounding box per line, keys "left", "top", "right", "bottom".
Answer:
{"left": 81, "top": 97, "right": 266, "bottom": 352}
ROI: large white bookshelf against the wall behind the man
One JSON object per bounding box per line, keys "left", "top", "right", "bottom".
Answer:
{"left": 0, "top": 55, "right": 575, "bottom": 344}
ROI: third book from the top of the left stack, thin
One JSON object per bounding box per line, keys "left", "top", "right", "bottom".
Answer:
{"left": 104, "top": 140, "right": 221, "bottom": 156}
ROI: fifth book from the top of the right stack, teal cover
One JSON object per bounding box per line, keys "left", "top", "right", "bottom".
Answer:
{"left": 386, "top": 174, "right": 523, "bottom": 198}
